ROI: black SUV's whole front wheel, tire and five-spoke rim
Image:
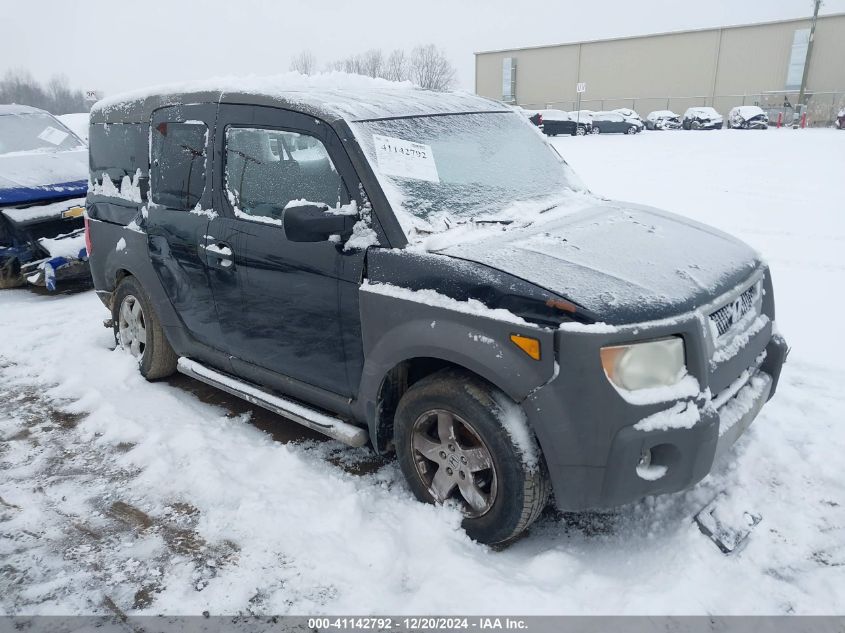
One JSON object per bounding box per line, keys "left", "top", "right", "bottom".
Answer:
{"left": 394, "top": 369, "right": 550, "bottom": 545}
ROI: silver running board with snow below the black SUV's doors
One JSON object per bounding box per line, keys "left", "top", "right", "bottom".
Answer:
{"left": 176, "top": 356, "right": 369, "bottom": 447}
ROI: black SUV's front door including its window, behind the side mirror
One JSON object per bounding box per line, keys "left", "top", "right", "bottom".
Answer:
{"left": 209, "top": 105, "right": 364, "bottom": 396}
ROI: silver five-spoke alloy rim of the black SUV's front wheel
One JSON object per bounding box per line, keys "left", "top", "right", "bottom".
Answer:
{"left": 411, "top": 409, "right": 498, "bottom": 518}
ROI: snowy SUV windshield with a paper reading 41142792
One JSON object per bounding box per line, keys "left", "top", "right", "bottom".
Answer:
{"left": 353, "top": 112, "right": 581, "bottom": 232}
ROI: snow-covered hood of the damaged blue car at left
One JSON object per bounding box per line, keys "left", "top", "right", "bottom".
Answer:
{"left": 0, "top": 149, "right": 88, "bottom": 205}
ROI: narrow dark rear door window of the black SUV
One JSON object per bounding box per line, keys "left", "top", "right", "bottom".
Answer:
{"left": 150, "top": 121, "right": 208, "bottom": 211}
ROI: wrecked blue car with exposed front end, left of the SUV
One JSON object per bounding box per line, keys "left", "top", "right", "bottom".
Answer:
{"left": 0, "top": 105, "right": 89, "bottom": 290}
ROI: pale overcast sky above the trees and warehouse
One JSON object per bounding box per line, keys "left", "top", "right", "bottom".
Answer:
{"left": 0, "top": 0, "right": 845, "bottom": 94}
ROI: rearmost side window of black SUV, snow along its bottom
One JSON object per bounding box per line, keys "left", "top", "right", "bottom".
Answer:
{"left": 88, "top": 123, "right": 150, "bottom": 200}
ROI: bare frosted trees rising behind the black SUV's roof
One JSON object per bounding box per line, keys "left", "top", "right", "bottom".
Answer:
{"left": 290, "top": 44, "right": 455, "bottom": 90}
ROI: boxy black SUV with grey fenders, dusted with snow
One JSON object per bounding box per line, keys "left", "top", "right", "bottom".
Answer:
{"left": 87, "top": 80, "right": 786, "bottom": 543}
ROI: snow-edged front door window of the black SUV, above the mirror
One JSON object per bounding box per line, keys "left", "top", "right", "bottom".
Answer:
{"left": 225, "top": 127, "right": 347, "bottom": 222}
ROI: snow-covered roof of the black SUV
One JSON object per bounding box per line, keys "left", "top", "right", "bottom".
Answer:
{"left": 91, "top": 72, "right": 513, "bottom": 123}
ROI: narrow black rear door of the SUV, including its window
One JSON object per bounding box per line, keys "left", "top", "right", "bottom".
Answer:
{"left": 146, "top": 104, "right": 220, "bottom": 349}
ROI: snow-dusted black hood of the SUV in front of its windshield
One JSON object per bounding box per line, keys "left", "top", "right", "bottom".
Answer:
{"left": 439, "top": 202, "right": 762, "bottom": 324}
